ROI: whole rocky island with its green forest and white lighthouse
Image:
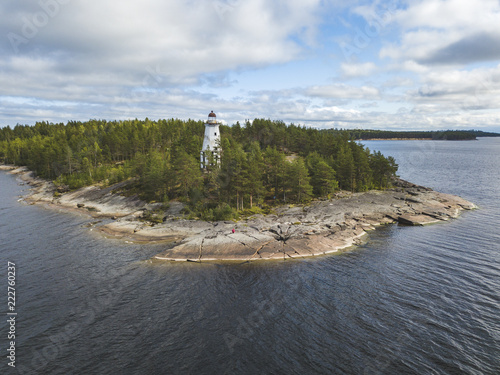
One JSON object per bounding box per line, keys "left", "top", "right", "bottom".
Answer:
{"left": 0, "top": 119, "right": 475, "bottom": 262}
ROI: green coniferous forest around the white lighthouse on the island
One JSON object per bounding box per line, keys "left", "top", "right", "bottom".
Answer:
{"left": 0, "top": 118, "right": 398, "bottom": 220}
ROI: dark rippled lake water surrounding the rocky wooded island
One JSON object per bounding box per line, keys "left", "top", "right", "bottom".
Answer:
{"left": 0, "top": 139, "right": 500, "bottom": 374}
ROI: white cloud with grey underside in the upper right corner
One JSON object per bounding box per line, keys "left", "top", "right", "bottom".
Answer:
{"left": 380, "top": 0, "right": 500, "bottom": 65}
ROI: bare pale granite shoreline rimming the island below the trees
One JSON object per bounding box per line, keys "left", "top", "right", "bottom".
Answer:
{"left": 0, "top": 166, "right": 476, "bottom": 262}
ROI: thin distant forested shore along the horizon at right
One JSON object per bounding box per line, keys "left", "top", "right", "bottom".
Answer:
{"left": 340, "top": 129, "right": 500, "bottom": 141}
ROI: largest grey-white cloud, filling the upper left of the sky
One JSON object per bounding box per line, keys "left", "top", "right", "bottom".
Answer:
{"left": 0, "top": 0, "right": 319, "bottom": 88}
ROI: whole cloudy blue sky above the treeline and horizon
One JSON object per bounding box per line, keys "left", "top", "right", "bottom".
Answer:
{"left": 0, "top": 0, "right": 500, "bottom": 132}
